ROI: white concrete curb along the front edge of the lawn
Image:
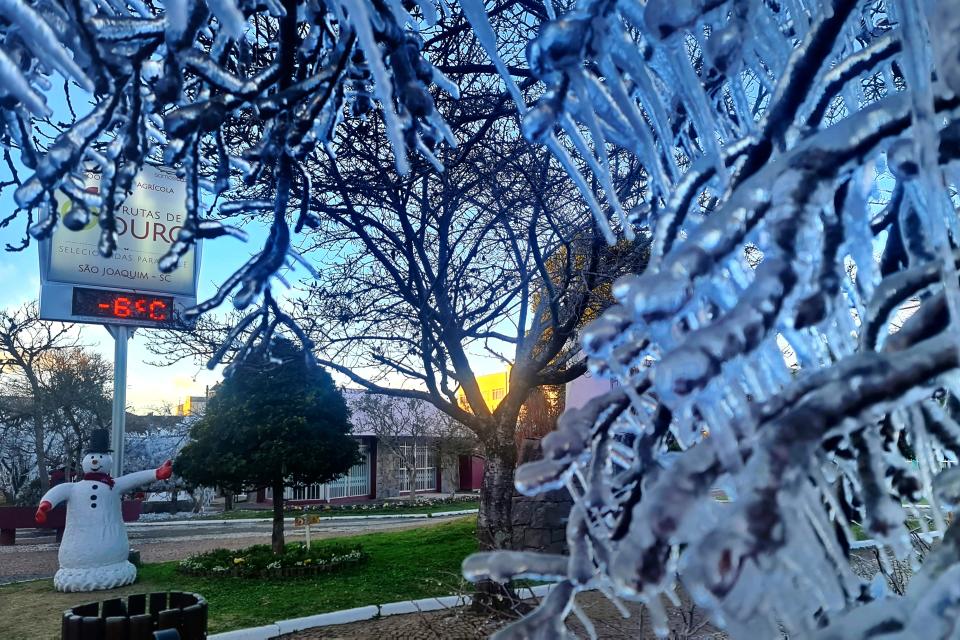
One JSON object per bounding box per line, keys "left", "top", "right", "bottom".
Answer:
{"left": 207, "top": 584, "right": 554, "bottom": 640}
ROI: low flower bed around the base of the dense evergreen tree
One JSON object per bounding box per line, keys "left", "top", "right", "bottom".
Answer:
{"left": 177, "top": 542, "right": 367, "bottom": 578}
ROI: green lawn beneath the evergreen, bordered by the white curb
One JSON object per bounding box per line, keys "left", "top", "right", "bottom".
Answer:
{"left": 0, "top": 517, "right": 477, "bottom": 640}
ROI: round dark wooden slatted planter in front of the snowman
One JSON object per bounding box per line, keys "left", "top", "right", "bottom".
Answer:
{"left": 60, "top": 591, "right": 207, "bottom": 640}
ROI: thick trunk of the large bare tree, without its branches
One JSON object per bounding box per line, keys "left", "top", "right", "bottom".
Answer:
{"left": 473, "top": 424, "right": 517, "bottom": 611}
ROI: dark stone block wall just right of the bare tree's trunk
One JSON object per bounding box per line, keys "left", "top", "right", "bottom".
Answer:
{"left": 511, "top": 440, "right": 573, "bottom": 553}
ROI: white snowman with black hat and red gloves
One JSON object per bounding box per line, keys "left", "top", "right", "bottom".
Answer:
{"left": 36, "top": 429, "right": 173, "bottom": 591}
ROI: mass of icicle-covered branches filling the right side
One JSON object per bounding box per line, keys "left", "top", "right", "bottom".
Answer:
{"left": 464, "top": 0, "right": 960, "bottom": 639}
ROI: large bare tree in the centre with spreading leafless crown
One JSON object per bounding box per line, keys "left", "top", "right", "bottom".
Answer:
{"left": 131, "top": 3, "right": 649, "bottom": 604}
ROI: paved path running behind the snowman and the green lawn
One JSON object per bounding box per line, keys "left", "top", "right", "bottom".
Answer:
{"left": 0, "top": 516, "right": 458, "bottom": 584}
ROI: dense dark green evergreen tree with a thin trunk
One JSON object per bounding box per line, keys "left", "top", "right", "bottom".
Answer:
{"left": 175, "top": 339, "right": 358, "bottom": 554}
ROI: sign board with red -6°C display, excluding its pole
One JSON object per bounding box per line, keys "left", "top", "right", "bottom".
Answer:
{"left": 40, "top": 166, "right": 200, "bottom": 327}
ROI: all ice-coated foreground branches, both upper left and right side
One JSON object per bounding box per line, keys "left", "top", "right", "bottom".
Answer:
{"left": 0, "top": 0, "right": 960, "bottom": 638}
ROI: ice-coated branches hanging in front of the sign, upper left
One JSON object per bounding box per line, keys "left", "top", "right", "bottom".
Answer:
{"left": 0, "top": 0, "right": 456, "bottom": 360}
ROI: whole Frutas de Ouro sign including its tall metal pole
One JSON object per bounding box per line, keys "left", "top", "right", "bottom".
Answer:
{"left": 36, "top": 168, "right": 200, "bottom": 476}
